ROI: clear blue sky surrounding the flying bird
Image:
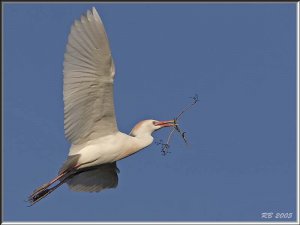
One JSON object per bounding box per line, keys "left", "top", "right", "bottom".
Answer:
{"left": 3, "top": 3, "right": 296, "bottom": 221}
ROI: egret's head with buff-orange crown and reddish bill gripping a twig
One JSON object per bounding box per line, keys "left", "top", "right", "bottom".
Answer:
{"left": 130, "top": 120, "right": 176, "bottom": 137}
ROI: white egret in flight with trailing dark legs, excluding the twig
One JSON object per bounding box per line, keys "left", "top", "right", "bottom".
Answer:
{"left": 28, "top": 7, "right": 176, "bottom": 205}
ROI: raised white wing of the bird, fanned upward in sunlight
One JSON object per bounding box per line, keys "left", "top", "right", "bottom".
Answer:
{"left": 64, "top": 7, "right": 118, "bottom": 144}
